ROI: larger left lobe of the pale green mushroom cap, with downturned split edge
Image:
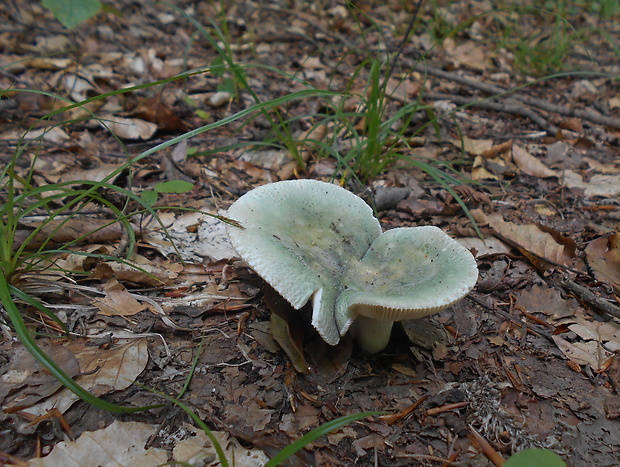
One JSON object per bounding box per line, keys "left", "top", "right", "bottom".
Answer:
{"left": 227, "top": 180, "right": 381, "bottom": 345}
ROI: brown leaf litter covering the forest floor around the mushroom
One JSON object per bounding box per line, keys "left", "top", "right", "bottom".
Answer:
{"left": 0, "top": 1, "right": 620, "bottom": 465}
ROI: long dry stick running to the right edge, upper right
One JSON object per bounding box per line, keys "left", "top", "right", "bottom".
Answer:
{"left": 410, "top": 62, "right": 620, "bottom": 129}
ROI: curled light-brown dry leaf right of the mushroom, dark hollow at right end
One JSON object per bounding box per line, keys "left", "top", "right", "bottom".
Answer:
{"left": 485, "top": 214, "right": 577, "bottom": 267}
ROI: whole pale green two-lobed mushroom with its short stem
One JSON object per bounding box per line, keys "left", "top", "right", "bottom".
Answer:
{"left": 227, "top": 180, "right": 478, "bottom": 353}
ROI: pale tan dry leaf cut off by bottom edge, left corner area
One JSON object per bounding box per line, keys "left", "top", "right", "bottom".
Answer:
{"left": 28, "top": 420, "right": 168, "bottom": 467}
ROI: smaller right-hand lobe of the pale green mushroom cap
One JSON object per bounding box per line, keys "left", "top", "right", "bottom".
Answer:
{"left": 339, "top": 226, "right": 478, "bottom": 321}
